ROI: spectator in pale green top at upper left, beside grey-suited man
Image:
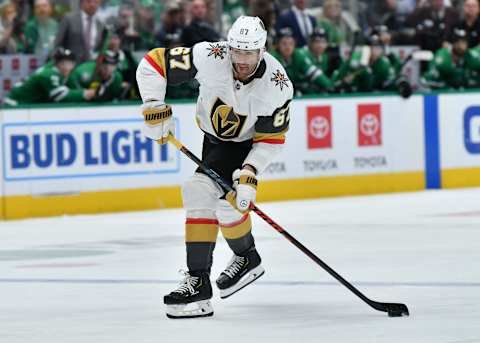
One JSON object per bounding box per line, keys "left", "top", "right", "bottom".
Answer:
{"left": 25, "top": 0, "right": 58, "bottom": 61}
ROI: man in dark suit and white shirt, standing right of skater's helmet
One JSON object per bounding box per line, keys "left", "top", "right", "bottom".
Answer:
{"left": 275, "top": 0, "right": 317, "bottom": 48}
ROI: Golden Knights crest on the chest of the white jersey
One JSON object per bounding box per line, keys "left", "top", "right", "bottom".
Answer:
{"left": 210, "top": 99, "right": 247, "bottom": 139}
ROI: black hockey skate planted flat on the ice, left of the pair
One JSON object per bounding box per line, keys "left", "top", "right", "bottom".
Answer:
{"left": 163, "top": 271, "right": 213, "bottom": 319}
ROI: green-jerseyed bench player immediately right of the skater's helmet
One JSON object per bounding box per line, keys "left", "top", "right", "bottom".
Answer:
{"left": 272, "top": 28, "right": 333, "bottom": 95}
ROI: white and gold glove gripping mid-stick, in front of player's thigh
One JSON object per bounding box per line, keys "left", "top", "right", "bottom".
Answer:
{"left": 226, "top": 168, "right": 258, "bottom": 213}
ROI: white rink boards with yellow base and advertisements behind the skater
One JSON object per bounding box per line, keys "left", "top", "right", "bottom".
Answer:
{"left": 0, "top": 95, "right": 480, "bottom": 219}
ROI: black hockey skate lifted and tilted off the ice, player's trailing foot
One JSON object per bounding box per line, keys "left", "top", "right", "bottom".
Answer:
{"left": 217, "top": 247, "right": 265, "bottom": 299}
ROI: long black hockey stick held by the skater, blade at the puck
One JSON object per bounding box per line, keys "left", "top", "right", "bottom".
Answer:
{"left": 168, "top": 135, "right": 409, "bottom": 317}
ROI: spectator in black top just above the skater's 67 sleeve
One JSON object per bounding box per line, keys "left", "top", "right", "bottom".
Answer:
{"left": 180, "top": 0, "right": 221, "bottom": 46}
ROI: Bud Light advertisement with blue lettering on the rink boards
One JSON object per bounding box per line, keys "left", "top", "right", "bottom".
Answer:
{"left": 2, "top": 119, "right": 180, "bottom": 181}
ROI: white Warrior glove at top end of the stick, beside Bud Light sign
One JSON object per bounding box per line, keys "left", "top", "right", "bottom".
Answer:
{"left": 142, "top": 101, "right": 175, "bottom": 144}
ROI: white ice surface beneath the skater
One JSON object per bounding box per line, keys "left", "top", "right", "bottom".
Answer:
{"left": 0, "top": 189, "right": 480, "bottom": 343}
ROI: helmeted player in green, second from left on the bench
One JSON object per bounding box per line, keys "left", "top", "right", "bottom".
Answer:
{"left": 67, "top": 50, "right": 123, "bottom": 101}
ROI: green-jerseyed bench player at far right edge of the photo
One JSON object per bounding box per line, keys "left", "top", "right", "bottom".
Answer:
{"left": 420, "top": 28, "right": 480, "bottom": 89}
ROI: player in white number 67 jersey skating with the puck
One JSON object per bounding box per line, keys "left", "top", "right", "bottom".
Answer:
{"left": 137, "top": 16, "right": 293, "bottom": 318}
